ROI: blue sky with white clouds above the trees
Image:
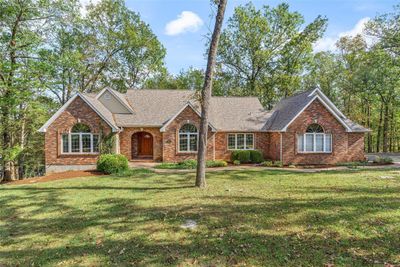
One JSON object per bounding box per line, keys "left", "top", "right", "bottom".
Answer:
{"left": 122, "top": 0, "right": 400, "bottom": 74}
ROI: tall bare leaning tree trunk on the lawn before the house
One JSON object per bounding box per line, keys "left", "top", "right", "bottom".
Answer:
{"left": 196, "top": 0, "right": 227, "bottom": 188}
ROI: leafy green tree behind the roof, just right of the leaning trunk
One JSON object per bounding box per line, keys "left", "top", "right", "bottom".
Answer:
{"left": 217, "top": 3, "right": 327, "bottom": 108}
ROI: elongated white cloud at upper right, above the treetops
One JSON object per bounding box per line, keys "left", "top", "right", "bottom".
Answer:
{"left": 314, "top": 17, "right": 372, "bottom": 52}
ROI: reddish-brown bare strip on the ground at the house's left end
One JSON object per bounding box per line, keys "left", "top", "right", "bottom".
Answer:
{"left": 1, "top": 170, "right": 104, "bottom": 184}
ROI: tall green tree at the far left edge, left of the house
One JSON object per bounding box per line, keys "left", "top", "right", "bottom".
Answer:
{"left": 0, "top": 0, "right": 69, "bottom": 180}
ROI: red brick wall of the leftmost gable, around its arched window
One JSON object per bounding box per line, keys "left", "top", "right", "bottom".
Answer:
{"left": 45, "top": 97, "right": 111, "bottom": 165}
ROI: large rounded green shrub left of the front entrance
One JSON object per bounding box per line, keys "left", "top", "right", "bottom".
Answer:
{"left": 97, "top": 154, "right": 128, "bottom": 174}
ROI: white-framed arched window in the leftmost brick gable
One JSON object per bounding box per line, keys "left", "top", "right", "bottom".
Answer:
{"left": 61, "top": 123, "right": 100, "bottom": 154}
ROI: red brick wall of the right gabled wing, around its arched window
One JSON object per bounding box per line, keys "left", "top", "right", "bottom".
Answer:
{"left": 282, "top": 100, "right": 364, "bottom": 164}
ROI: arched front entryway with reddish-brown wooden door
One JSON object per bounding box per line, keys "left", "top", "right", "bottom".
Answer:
{"left": 132, "top": 132, "right": 153, "bottom": 159}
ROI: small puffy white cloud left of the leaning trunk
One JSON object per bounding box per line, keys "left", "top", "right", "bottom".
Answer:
{"left": 165, "top": 11, "right": 204, "bottom": 35}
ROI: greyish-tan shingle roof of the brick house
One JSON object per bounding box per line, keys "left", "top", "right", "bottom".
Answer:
{"left": 79, "top": 89, "right": 369, "bottom": 132}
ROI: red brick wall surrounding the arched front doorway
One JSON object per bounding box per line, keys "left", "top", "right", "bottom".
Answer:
{"left": 119, "top": 127, "right": 162, "bottom": 161}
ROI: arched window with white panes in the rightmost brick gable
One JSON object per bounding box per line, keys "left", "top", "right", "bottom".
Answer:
{"left": 297, "top": 123, "right": 332, "bottom": 153}
